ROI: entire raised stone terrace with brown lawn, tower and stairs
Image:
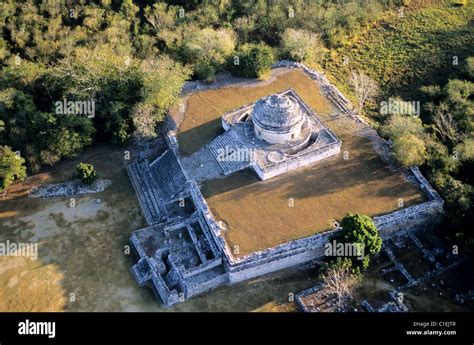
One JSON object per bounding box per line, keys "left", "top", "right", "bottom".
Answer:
{"left": 128, "top": 62, "right": 443, "bottom": 305}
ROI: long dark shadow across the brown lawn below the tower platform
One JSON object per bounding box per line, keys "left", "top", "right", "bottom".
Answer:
{"left": 203, "top": 137, "right": 423, "bottom": 207}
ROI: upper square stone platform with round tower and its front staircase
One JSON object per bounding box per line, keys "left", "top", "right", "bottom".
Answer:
{"left": 209, "top": 89, "right": 341, "bottom": 180}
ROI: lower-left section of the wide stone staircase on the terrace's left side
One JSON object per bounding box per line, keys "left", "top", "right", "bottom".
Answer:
{"left": 127, "top": 159, "right": 167, "bottom": 225}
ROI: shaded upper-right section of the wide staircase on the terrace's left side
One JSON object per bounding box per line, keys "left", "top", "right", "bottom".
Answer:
{"left": 150, "top": 150, "right": 186, "bottom": 202}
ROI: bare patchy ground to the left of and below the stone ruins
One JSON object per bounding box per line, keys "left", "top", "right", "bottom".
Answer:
{"left": 0, "top": 145, "right": 328, "bottom": 311}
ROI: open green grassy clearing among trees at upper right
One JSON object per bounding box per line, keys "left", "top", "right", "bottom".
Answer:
{"left": 324, "top": 1, "right": 474, "bottom": 111}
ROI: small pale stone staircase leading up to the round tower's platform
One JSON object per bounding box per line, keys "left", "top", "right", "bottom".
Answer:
{"left": 208, "top": 131, "right": 250, "bottom": 175}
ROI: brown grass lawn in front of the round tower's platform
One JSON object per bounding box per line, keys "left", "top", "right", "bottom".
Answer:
{"left": 203, "top": 137, "right": 423, "bottom": 255}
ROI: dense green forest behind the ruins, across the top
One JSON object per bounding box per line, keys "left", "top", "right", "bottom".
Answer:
{"left": 0, "top": 0, "right": 474, "bottom": 250}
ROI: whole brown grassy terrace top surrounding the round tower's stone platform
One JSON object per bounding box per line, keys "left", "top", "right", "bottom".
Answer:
{"left": 179, "top": 71, "right": 424, "bottom": 256}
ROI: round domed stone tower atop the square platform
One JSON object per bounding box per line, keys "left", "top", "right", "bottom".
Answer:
{"left": 252, "top": 95, "right": 306, "bottom": 144}
